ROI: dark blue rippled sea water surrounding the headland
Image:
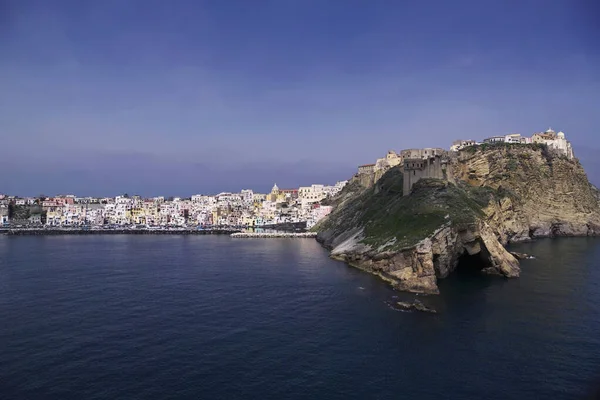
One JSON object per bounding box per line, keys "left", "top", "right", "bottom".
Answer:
{"left": 0, "top": 235, "right": 600, "bottom": 399}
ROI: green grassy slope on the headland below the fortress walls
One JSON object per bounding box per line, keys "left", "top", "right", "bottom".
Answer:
{"left": 315, "top": 168, "right": 496, "bottom": 250}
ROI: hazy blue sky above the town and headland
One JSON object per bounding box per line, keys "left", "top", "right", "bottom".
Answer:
{"left": 0, "top": 0, "right": 600, "bottom": 196}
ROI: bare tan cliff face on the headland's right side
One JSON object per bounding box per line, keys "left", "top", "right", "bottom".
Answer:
{"left": 453, "top": 146, "right": 600, "bottom": 242}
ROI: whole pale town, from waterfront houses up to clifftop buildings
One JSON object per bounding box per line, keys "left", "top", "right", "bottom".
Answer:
{"left": 0, "top": 128, "right": 574, "bottom": 234}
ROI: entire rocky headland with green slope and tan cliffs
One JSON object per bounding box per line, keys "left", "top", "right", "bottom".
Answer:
{"left": 315, "top": 145, "right": 600, "bottom": 293}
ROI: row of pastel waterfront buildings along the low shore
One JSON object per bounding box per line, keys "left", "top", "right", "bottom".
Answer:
{"left": 0, "top": 181, "right": 346, "bottom": 228}
